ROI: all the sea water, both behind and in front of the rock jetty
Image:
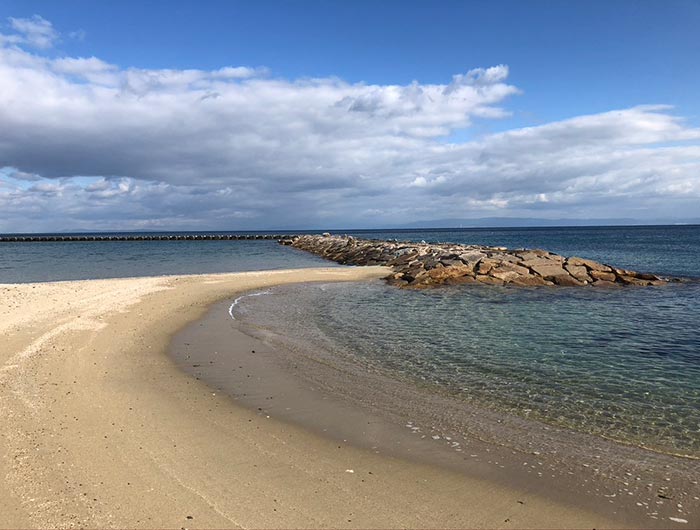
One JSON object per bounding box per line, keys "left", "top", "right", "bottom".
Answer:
{"left": 0, "top": 226, "right": 700, "bottom": 459}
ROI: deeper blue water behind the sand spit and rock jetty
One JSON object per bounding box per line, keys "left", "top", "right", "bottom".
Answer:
{"left": 0, "top": 226, "right": 700, "bottom": 283}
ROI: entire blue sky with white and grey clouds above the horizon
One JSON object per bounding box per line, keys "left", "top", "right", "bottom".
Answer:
{"left": 0, "top": 0, "right": 700, "bottom": 232}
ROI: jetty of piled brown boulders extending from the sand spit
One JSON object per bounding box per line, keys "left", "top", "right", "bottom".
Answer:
{"left": 280, "top": 233, "right": 670, "bottom": 288}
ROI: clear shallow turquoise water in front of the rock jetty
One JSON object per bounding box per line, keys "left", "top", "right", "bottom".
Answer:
{"left": 235, "top": 282, "right": 700, "bottom": 457}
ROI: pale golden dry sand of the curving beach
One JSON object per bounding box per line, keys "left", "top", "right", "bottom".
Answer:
{"left": 0, "top": 267, "right": 619, "bottom": 528}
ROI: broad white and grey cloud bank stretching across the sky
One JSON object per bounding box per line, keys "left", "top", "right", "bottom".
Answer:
{"left": 0, "top": 17, "right": 700, "bottom": 231}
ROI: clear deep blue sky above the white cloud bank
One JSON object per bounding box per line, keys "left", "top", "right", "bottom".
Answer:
{"left": 3, "top": 0, "right": 700, "bottom": 122}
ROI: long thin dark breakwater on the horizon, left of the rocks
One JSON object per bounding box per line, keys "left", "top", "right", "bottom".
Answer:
{"left": 0, "top": 234, "right": 296, "bottom": 243}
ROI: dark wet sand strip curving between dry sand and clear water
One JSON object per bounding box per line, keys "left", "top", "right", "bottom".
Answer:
{"left": 170, "top": 293, "right": 700, "bottom": 528}
